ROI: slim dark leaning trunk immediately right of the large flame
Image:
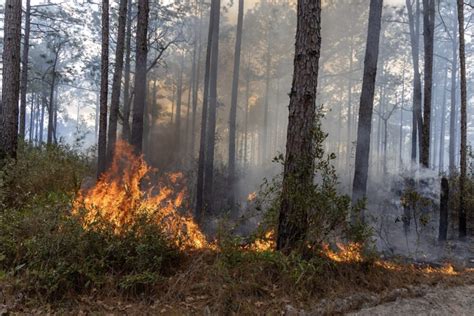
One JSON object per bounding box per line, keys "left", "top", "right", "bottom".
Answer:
{"left": 195, "top": 1, "right": 215, "bottom": 221}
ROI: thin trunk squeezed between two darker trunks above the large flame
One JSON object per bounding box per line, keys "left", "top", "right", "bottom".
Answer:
{"left": 122, "top": 0, "right": 133, "bottom": 142}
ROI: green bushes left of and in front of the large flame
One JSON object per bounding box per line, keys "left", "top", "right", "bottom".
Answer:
{"left": 0, "top": 147, "right": 179, "bottom": 300}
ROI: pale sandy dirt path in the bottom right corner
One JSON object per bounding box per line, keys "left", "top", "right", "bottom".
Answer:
{"left": 349, "top": 285, "right": 474, "bottom": 316}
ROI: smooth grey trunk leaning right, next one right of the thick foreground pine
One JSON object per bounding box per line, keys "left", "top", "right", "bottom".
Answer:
{"left": 352, "top": 0, "right": 383, "bottom": 221}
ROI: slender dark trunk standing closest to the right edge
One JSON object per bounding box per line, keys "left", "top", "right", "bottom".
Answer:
{"left": 457, "top": 0, "right": 467, "bottom": 238}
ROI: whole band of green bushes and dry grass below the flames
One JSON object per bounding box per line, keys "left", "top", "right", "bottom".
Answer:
{"left": 0, "top": 147, "right": 467, "bottom": 314}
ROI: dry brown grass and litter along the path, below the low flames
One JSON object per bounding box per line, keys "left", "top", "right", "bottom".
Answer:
{"left": 0, "top": 250, "right": 474, "bottom": 315}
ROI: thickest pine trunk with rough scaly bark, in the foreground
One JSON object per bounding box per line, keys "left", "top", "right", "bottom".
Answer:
{"left": 277, "top": 0, "right": 321, "bottom": 253}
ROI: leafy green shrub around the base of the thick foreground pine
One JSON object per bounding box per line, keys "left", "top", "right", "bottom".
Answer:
{"left": 252, "top": 109, "right": 372, "bottom": 249}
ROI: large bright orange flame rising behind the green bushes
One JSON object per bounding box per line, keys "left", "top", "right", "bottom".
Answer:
{"left": 74, "top": 141, "right": 208, "bottom": 249}
